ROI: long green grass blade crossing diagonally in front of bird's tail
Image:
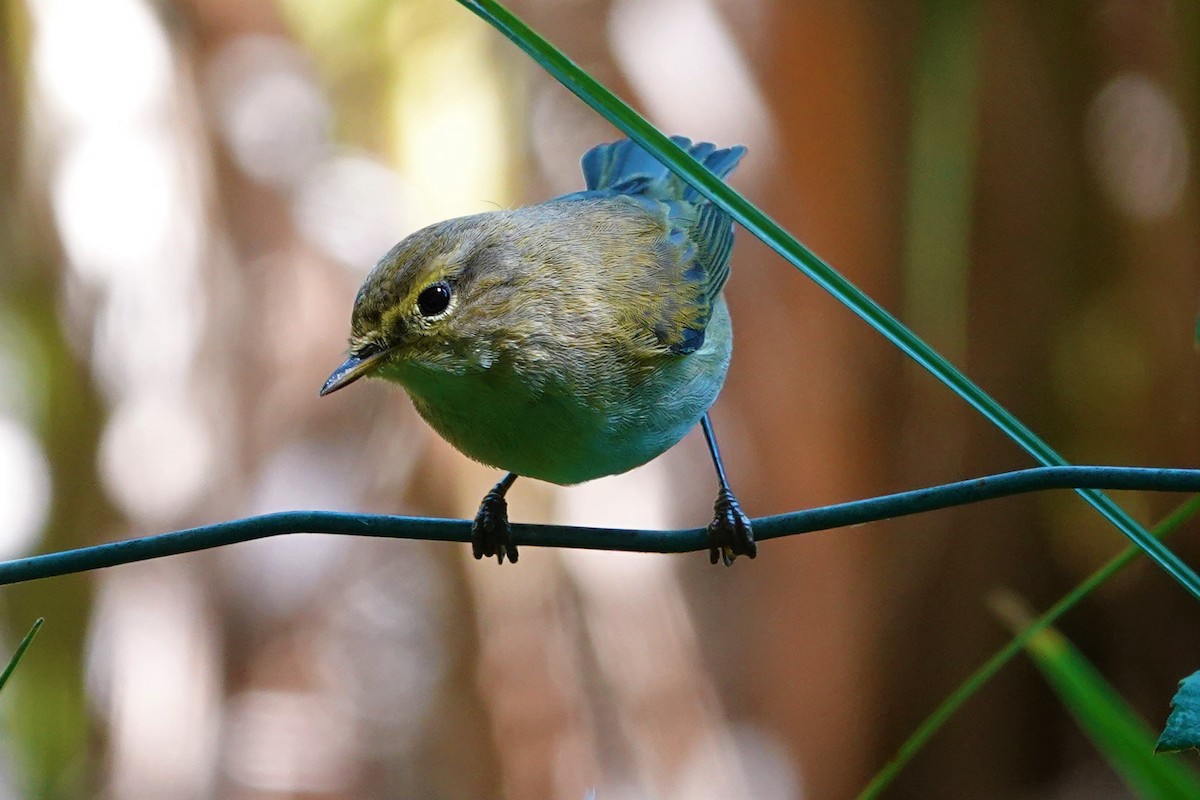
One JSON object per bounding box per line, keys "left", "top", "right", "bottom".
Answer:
{"left": 458, "top": 0, "right": 1200, "bottom": 600}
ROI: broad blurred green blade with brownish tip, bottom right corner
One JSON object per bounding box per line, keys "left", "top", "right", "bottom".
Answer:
{"left": 995, "top": 594, "right": 1200, "bottom": 800}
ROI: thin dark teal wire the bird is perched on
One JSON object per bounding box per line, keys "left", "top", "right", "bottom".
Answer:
{"left": 0, "top": 467, "right": 1200, "bottom": 585}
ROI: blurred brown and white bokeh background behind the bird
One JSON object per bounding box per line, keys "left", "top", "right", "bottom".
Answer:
{"left": 0, "top": 0, "right": 1200, "bottom": 800}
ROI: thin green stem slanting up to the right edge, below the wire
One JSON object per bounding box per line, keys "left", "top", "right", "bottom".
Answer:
{"left": 858, "top": 495, "right": 1200, "bottom": 800}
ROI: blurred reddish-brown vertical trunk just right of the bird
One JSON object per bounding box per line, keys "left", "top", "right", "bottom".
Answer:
{"left": 710, "top": 2, "right": 904, "bottom": 798}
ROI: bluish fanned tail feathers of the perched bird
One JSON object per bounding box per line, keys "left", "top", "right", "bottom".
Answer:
{"left": 583, "top": 136, "right": 746, "bottom": 203}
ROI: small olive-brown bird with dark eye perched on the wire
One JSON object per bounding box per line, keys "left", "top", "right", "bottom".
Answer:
{"left": 320, "top": 137, "right": 756, "bottom": 564}
